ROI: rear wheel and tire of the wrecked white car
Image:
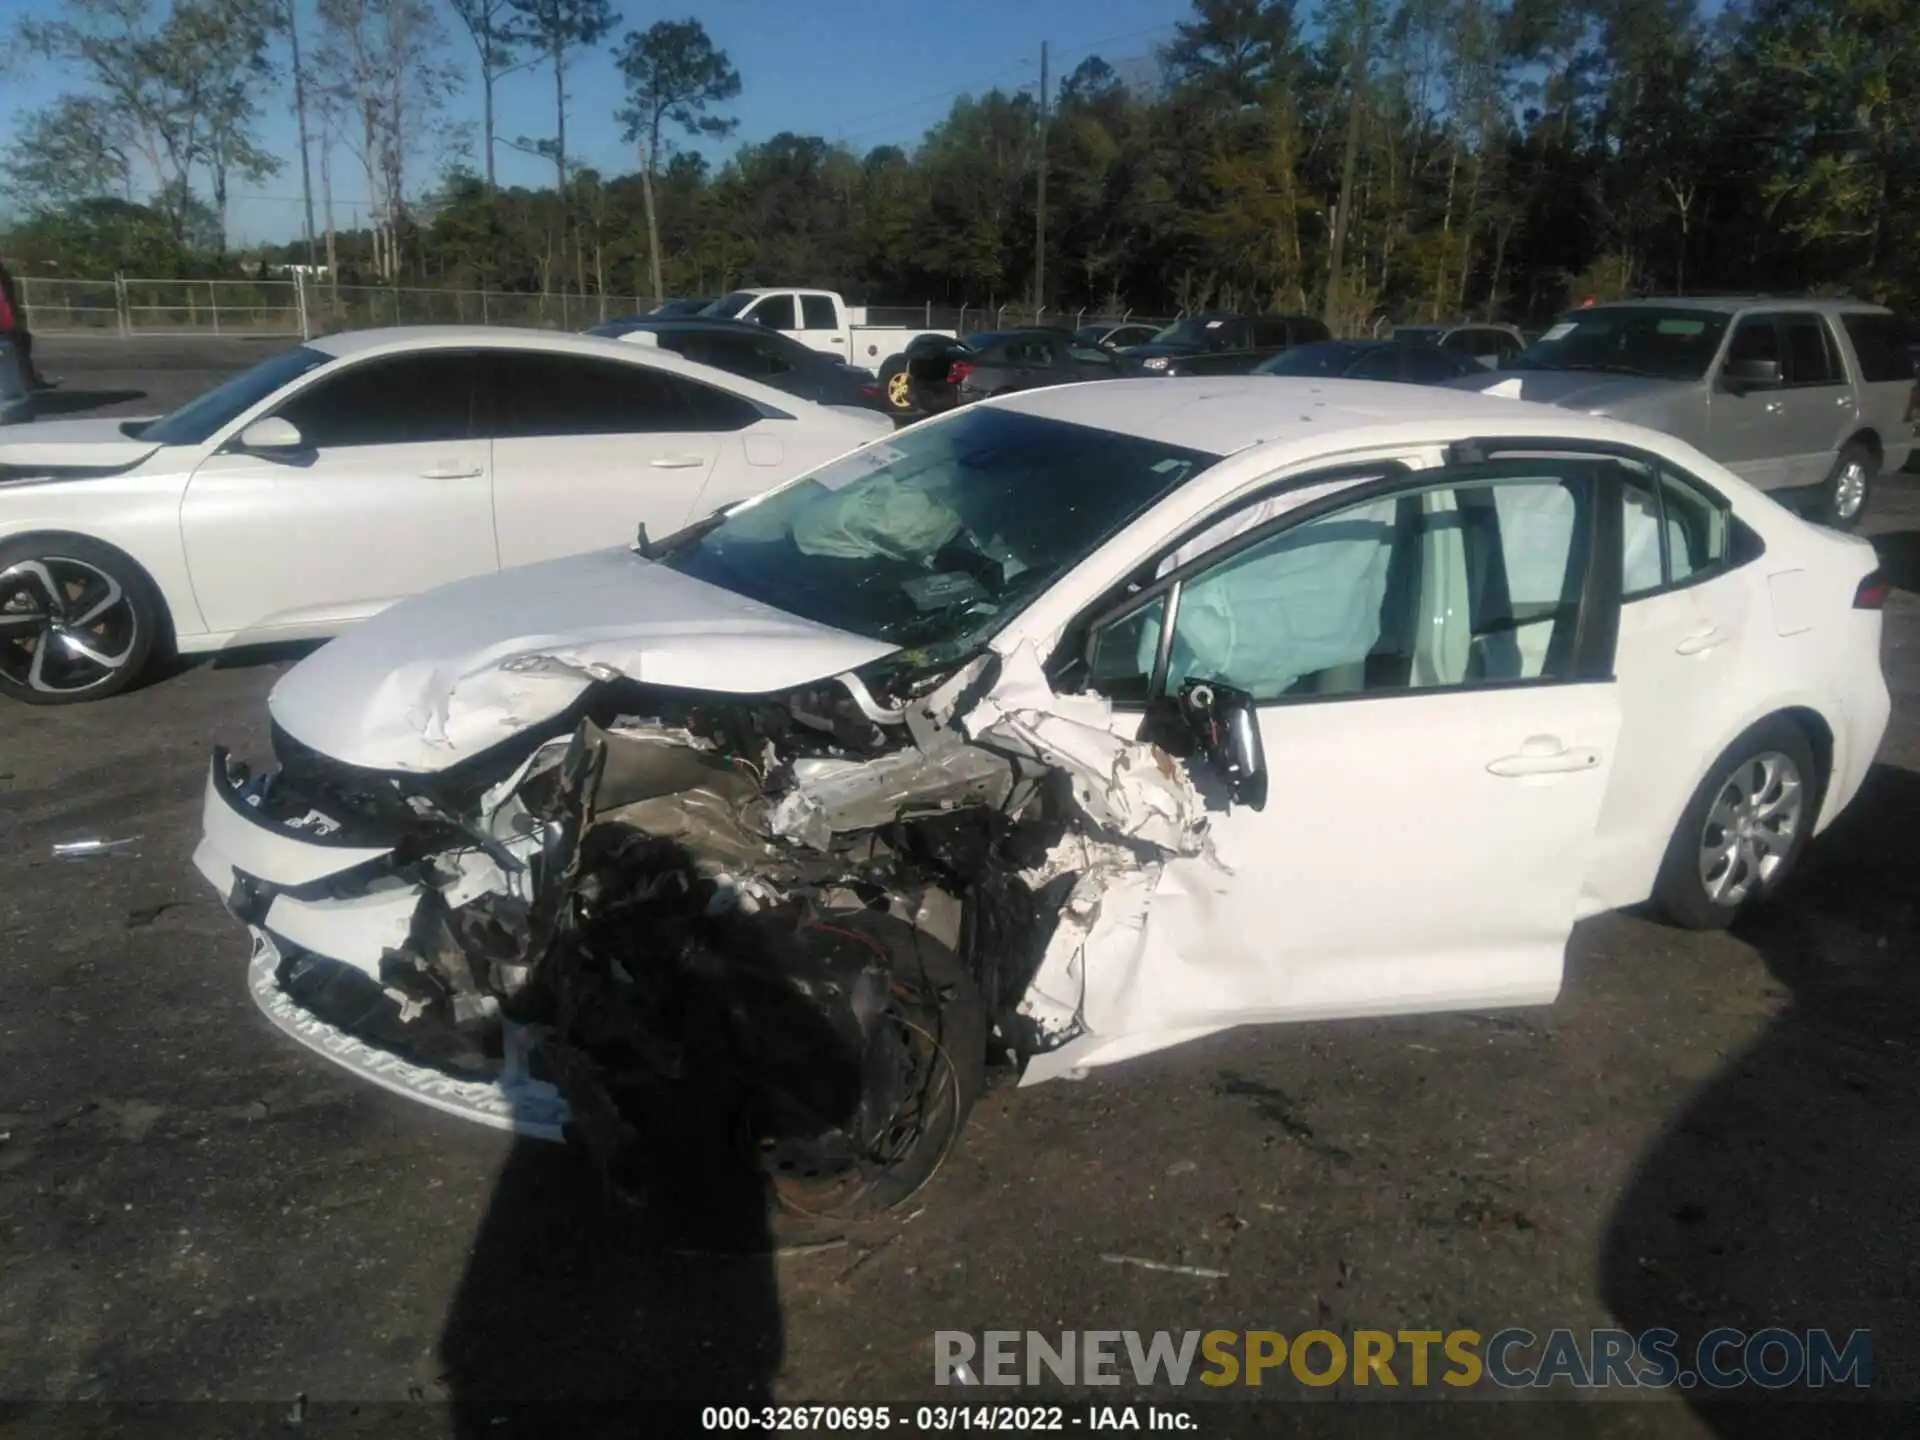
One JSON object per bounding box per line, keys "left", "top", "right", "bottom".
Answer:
{"left": 1653, "top": 716, "right": 1826, "bottom": 929}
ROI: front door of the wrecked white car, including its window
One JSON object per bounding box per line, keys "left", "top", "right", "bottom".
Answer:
{"left": 1085, "top": 459, "right": 1620, "bottom": 1037}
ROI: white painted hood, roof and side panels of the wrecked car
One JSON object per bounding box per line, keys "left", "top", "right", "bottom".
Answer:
{"left": 206, "top": 378, "right": 1889, "bottom": 1113}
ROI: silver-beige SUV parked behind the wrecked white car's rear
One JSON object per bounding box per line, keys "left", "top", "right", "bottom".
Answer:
{"left": 1453, "top": 298, "right": 1920, "bottom": 526}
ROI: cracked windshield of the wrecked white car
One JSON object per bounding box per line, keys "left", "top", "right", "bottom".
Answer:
{"left": 664, "top": 409, "right": 1219, "bottom": 664}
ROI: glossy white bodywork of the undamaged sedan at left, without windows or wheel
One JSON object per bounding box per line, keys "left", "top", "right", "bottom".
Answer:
{"left": 0, "top": 326, "right": 891, "bottom": 653}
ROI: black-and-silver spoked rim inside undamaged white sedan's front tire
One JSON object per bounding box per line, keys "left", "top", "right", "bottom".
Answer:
{"left": 0, "top": 555, "right": 140, "bottom": 695}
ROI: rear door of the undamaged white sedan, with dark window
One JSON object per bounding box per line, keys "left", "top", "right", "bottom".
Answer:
{"left": 488, "top": 349, "right": 760, "bottom": 564}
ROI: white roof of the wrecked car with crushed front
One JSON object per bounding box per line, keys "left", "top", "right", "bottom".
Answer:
{"left": 985, "top": 374, "right": 1617, "bottom": 455}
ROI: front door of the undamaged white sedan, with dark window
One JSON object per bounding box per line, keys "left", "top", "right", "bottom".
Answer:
{"left": 180, "top": 349, "right": 499, "bottom": 639}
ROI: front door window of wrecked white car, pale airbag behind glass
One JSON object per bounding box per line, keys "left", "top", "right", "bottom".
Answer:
{"left": 1089, "top": 461, "right": 1594, "bottom": 701}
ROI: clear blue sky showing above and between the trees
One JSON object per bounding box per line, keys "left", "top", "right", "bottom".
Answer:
{"left": 0, "top": 0, "right": 1190, "bottom": 244}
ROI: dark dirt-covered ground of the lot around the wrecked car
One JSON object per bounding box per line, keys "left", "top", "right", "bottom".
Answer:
{"left": 11, "top": 338, "right": 1920, "bottom": 1434}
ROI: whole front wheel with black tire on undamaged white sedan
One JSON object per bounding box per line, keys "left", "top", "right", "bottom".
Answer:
{"left": 0, "top": 536, "right": 167, "bottom": 705}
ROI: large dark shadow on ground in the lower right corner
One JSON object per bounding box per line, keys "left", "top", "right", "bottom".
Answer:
{"left": 1601, "top": 764, "right": 1920, "bottom": 1436}
